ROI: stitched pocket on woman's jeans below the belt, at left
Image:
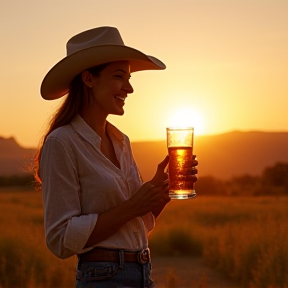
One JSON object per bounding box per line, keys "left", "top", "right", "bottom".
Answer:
{"left": 76, "top": 262, "right": 119, "bottom": 282}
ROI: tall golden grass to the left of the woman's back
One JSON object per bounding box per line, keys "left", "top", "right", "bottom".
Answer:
{"left": 0, "top": 192, "right": 76, "bottom": 288}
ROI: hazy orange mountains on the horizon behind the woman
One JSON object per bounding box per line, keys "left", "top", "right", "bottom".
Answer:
{"left": 0, "top": 131, "right": 288, "bottom": 181}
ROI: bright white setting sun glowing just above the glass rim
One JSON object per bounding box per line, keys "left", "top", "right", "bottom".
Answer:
{"left": 168, "top": 107, "right": 205, "bottom": 135}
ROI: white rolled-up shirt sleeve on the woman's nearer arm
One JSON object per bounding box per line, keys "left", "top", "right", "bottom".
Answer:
{"left": 40, "top": 136, "right": 98, "bottom": 259}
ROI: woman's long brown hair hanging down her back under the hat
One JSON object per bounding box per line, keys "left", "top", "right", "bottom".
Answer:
{"left": 34, "top": 63, "right": 108, "bottom": 184}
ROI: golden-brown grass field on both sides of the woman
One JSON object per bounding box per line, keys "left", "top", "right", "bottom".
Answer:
{"left": 0, "top": 192, "right": 288, "bottom": 288}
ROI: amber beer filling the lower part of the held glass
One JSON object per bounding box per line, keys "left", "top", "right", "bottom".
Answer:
{"left": 168, "top": 147, "right": 196, "bottom": 199}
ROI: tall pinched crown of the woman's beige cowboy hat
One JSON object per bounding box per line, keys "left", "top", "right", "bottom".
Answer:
{"left": 66, "top": 27, "right": 124, "bottom": 56}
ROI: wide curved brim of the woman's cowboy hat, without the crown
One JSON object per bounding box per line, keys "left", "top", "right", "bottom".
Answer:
{"left": 40, "top": 45, "right": 166, "bottom": 100}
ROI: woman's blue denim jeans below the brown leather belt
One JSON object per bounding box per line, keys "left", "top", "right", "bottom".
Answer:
{"left": 76, "top": 262, "right": 155, "bottom": 288}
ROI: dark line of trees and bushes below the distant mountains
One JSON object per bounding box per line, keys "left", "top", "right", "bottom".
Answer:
{"left": 0, "top": 162, "right": 288, "bottom": 196}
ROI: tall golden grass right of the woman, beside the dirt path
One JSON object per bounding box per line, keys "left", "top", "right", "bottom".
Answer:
{"left": 150, "top": 197, "right": 288, "bottom": 288}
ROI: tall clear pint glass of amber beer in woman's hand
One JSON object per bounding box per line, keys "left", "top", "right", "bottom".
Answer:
{"left": 167, "top": 127, "right": 196, "bottom": 199}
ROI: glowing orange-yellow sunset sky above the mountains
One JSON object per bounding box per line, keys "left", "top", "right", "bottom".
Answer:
{"left": 0, "top": 0, "right": 288, "bottom": 147}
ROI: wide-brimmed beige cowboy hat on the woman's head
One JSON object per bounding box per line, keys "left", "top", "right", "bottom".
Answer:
{"left": 41, "top": 27, "right": 166, "bottom": 100}
